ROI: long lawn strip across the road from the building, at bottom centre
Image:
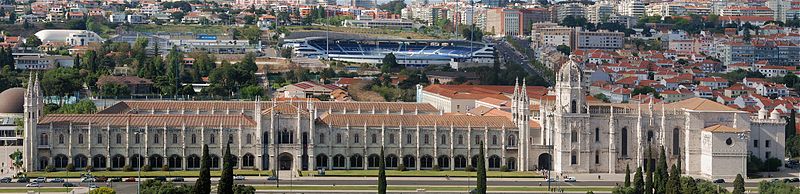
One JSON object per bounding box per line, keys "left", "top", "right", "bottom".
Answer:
{"left": 254, "top": 185, "right": 614, "bottom": 192}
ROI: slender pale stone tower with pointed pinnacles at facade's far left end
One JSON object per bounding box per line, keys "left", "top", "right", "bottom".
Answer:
{"left": 22, "top": 74, "right": 44, "bottom": 171}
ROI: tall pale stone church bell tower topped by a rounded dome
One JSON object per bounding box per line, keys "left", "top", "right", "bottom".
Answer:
{"left": 545, "top": 56, "right": 592, "bottom": 172}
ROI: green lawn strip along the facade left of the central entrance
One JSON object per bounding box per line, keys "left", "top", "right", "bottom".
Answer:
{"left": 27, "top": 170, "right": 271, "bottom": 178}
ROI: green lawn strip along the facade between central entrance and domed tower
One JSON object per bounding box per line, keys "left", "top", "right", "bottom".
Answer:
{"left": 318, "top": 170, "right": 543, "bottom": 178}
